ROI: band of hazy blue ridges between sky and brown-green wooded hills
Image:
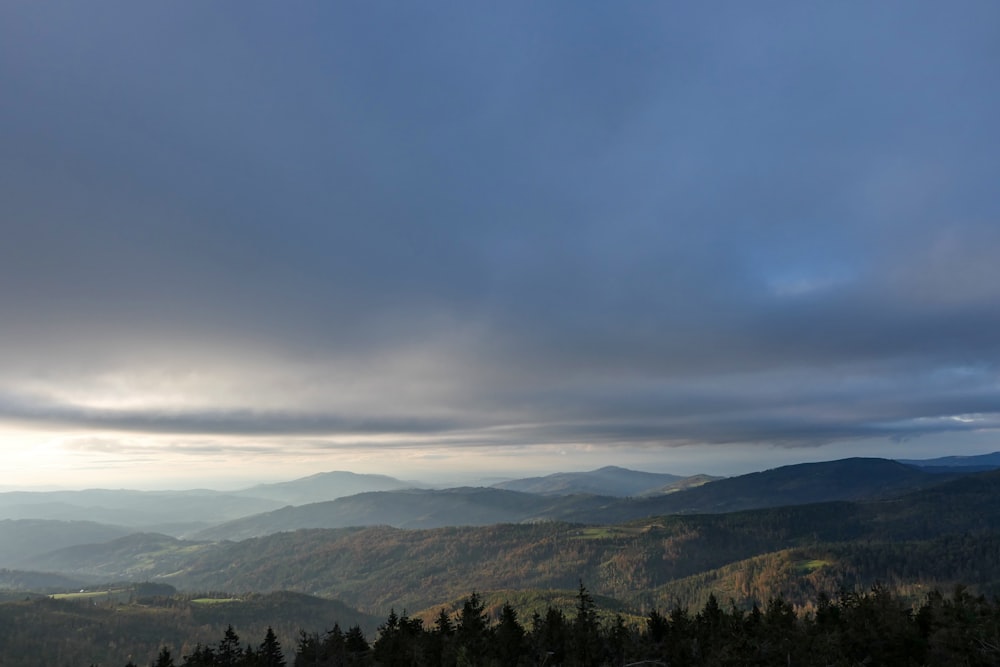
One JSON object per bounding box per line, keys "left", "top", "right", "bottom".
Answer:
{"left": 0, "top": 453, "right": 1000, "bottom": 568}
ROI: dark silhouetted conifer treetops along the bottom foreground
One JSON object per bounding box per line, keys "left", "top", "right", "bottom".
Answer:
{"left": 29, "top": 583, "right": 1000, "bottom": 667}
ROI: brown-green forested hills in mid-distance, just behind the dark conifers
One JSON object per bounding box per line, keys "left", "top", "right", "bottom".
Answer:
{"left": 17, "top": 468, "right": 1000, "bottom": 613}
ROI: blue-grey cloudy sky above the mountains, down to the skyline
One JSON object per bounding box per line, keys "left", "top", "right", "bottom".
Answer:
{"left": 0, "top": 0, "right": 1000, "bottom": 488}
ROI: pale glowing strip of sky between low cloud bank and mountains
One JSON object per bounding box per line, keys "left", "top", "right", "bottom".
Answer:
{"left": 0, "top": 431, "right": 1000, "bottom": 491}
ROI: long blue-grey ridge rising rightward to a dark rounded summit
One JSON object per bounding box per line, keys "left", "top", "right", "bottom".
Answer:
{"left": 193, "top": 458, "right": 960, "bottom": 540}
